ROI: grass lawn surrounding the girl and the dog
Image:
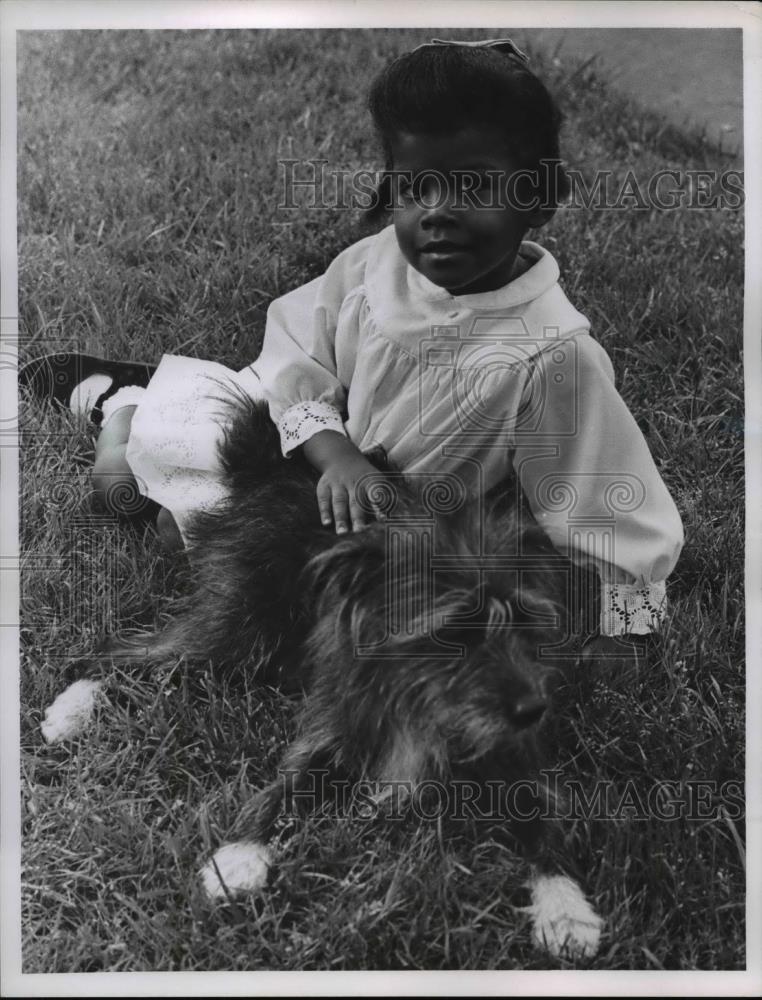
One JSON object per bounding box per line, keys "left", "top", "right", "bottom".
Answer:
{"left": 18, "top": 30, "right": 745, "bottom": 972}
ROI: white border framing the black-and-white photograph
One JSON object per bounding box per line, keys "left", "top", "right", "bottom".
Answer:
{"left": 0, "top": 0, "right": 762, "bottom": 997}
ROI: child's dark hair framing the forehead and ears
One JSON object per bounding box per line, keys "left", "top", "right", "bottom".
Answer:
{"left": 368, "top": 45, "right": 569, "bottom": 214}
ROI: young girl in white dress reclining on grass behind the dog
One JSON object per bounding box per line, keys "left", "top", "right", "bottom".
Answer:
{"left": 22, "top": 39, "right": 682, "bottom": 652}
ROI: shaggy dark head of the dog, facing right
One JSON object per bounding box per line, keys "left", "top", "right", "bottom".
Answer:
{"left": 308, "top": 500, "right": 563, "bottom": 778}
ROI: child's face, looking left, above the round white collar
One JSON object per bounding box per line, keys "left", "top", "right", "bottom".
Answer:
{"left": 391, "top": 125, "right": 549, "bottom": 295}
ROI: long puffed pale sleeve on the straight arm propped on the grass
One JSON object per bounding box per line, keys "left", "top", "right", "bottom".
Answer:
{"left": 514, "top": 334, "right": 683, "bottom": 635}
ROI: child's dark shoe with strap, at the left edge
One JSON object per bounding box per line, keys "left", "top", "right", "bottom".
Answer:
{"left": 19, "top": 354, "right": 156, "bottom": 424}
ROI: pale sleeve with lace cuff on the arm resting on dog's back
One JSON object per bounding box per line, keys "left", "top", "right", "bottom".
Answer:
{"left": 253, "top": 237, "right": 374, "bottom": 455}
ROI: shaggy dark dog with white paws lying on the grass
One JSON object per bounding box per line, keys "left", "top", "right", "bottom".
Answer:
{"left": 43, "top": 394, "right": 601, "bottom": 957}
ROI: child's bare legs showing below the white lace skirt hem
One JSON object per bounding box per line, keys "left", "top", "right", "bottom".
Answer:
{"left": 92, "top": 406, "right": 183, "bottom": 551}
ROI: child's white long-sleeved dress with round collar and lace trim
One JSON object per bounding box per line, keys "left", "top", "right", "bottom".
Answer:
{"left": 127, "top": 226, "right": 683, "bottom": 635}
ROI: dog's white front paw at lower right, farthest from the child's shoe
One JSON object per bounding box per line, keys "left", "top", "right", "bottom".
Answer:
{"left": 529, "top": 875, "right": 603, "bottom": 958}
